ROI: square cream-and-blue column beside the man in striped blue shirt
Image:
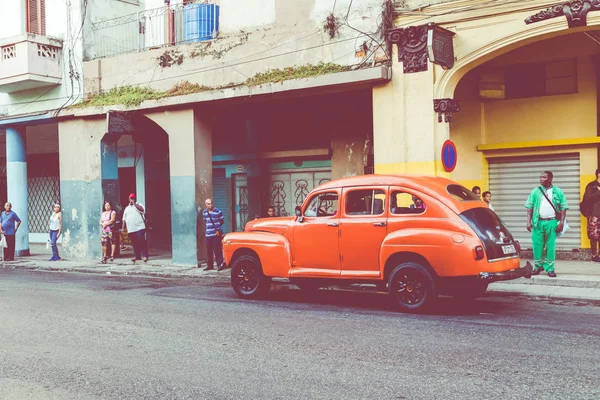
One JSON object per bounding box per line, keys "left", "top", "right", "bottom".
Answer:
{"left": 146, "top": 109, "right": 212, "bottom": 265}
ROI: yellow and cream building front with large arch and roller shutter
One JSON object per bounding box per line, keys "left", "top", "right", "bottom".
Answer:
{"left": 380, "top": 0, "right": 600, "bottom": 250}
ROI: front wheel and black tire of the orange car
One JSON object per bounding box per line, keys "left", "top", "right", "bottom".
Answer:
{"left": 231, "top": 255, "right": 271, "bottom": 299}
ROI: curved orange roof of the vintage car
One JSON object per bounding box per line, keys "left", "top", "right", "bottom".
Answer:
{"left": 315, "top": 174, "right": 486, "bottom": 214}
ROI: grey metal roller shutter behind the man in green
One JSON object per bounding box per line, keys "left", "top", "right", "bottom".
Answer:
{"left": 482, "top": 154, "right": 581, "bottom": 250}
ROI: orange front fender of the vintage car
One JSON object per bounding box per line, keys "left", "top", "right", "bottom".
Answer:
{"left": 223, "top": 232, "right": 292, "bottom": 277}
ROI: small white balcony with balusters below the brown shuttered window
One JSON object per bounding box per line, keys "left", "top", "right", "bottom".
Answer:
{"left": 0, "top": 34, "right": 62, "bottom": 93}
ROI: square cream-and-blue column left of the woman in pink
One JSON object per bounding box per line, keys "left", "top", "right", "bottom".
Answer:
{"left": 58, "top": 118, "right": 105, "bottom": 260}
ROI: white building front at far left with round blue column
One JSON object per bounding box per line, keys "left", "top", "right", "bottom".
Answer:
{"left": 0, "top": 0, "right": 88, "bottom": 255}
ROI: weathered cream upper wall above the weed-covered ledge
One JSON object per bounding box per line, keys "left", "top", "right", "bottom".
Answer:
{"left": 84, "top": 0, "right": 382, "bottom": 93}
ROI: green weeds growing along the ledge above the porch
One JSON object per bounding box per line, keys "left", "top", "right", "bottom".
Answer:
{"left": 69, "top": 63, "right": 350, "bottom": 108}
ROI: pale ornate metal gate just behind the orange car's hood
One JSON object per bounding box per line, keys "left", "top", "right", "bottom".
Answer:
{"left": 269, "top": 170, "right": 331, "bottom": 217}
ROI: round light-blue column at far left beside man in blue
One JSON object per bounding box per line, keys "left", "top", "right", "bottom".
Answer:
{"left": 3, "top": 127, "right": 29, "bottom": 256}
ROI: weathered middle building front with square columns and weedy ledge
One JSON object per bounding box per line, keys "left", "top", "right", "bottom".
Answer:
{"left": 58, "top": 0, "right": 392, "bottom": 264}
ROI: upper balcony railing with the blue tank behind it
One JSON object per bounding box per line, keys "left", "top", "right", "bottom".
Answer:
{"left": 88, "top": 0, "right": 220, "bottom": 59}
